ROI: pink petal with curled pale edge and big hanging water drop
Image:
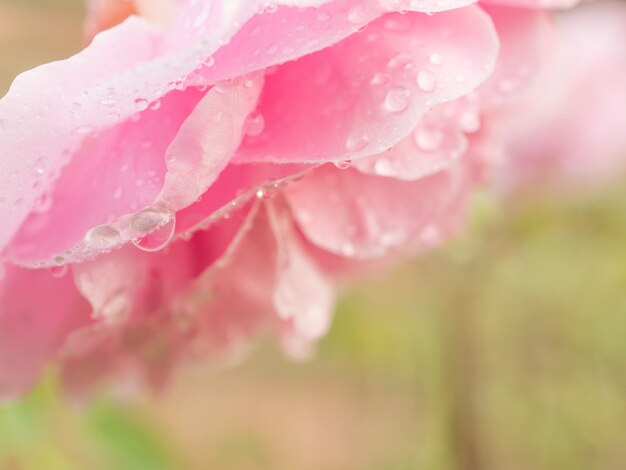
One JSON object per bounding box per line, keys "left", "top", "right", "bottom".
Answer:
{"left": 8, "top": 78, "right": 261, "bottom": 265}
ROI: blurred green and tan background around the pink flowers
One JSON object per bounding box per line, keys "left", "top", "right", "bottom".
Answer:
{"left": 0, "top": 0, "right": 626, "bottom": 470}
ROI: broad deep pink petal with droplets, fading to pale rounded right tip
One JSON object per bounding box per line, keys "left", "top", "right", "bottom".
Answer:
{"left": 236, "top": 7, "right": 498, "bottom": 163}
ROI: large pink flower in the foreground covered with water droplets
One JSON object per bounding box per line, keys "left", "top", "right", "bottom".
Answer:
{"left": 0, "top": 0, "right": 620, "bottom": 395}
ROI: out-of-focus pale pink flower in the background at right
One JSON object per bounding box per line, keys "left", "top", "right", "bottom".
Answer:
{"left": 488, "top": 2, "right": 626, "bottom": 192}
